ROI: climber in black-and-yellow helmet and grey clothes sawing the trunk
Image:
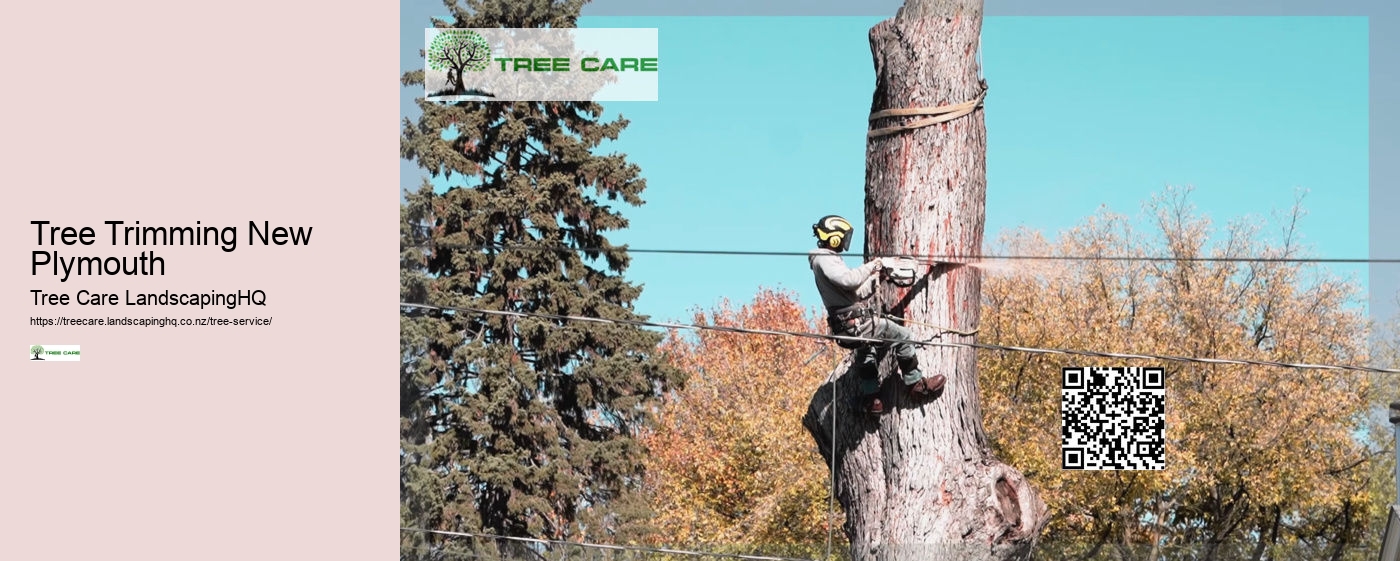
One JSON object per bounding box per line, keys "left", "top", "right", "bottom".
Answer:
{"left": 808, "top": 214, "right": 948, "bottom": 414}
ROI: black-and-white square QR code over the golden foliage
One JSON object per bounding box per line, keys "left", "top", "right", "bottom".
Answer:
{"left": 1060, "top": 367, "right": 1166, "bottom": 470}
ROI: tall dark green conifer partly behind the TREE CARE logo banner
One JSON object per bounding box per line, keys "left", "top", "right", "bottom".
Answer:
{"left": 400, "top": 0, "right": 680, "bottom": 560}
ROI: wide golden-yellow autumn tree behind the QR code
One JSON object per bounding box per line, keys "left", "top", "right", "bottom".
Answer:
{"left": 980, "top": 189, "right": 1382, "bottom": 560}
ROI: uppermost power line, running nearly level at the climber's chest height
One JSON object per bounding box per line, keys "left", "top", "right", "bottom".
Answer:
{"left": 407, "top": 243, "right": 1400, "bottom": 264}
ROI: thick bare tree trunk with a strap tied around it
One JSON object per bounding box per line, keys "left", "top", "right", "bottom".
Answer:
{"left": 804, "top": 0, "right": 1046, "bottom": 561}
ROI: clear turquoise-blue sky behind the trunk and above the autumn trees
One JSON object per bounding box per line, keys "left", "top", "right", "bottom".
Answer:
{"left": 402, "top": 13, "right": 1368, "bottom": 320}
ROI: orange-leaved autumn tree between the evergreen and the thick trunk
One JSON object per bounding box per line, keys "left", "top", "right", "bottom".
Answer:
{"left": 643, "top": 290, "right": 844, "bottom": 557}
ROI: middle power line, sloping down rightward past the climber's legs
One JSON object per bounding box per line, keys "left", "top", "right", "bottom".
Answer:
{"left": 399, "top": 302, "right": 1400, "bottom": 374}
